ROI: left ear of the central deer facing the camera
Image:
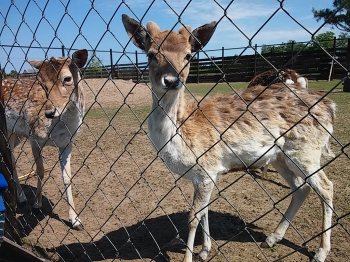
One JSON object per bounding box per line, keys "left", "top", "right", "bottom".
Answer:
{"left": 122, "top": 14, "right": 147, "bottom": 51}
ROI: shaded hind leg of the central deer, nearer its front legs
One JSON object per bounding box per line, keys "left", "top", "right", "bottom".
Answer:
{"left": 261, "top": 162, "right": 310, "bottom": 247}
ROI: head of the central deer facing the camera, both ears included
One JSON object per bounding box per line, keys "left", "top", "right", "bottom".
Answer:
{"left": 122, "top": 14, "right": 217, "bottom": 94}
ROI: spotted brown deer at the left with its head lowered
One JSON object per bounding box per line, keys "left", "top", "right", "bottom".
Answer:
{"left": 2, "top": 49, "right": 88, "bottom": 230}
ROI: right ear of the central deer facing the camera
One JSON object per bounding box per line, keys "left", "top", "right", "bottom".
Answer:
{"left": 190, "top": 21, "right": 217, "bottom": 53}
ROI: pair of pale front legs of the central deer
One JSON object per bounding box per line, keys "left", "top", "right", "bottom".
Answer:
{"left": 183, "top": 180, "right": 214, "bottom": 262}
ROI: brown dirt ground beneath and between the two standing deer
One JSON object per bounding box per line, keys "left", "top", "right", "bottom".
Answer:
{"left": 12, "top": 79, "right": 350, "bottom": 262}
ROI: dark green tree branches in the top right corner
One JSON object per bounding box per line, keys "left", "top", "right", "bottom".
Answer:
{"left": 312, "top": 0, "right": 350, "bottom": 32}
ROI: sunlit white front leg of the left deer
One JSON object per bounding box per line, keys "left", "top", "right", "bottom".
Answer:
{"left": 60, "top": 143, "right": 83, "bottom": 231}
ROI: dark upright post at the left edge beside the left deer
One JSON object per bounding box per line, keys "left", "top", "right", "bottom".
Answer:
{"left": 0, "top": 67, "right": 22, "bottom": 244}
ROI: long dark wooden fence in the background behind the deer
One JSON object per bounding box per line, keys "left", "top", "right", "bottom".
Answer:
{"left": 84, "top": 39, "right": 350, "bottom": 83}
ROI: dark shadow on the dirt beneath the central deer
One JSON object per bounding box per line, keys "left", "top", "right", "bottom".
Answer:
{"left": 52, "top": 211, "right": 313, "bottom": 262}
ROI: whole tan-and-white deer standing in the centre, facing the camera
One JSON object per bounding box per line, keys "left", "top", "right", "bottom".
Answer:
{"left": 122, "top": 15, "right": 335, "bottom": 262}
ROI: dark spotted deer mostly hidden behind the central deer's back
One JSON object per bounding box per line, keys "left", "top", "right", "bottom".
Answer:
{"left": 248, "top": 68, "right": 308, "bottom": 88}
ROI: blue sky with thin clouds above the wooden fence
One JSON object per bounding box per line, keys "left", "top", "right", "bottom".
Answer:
{"left": 0, "top": 0, "right": 340, "bottom": 73}
